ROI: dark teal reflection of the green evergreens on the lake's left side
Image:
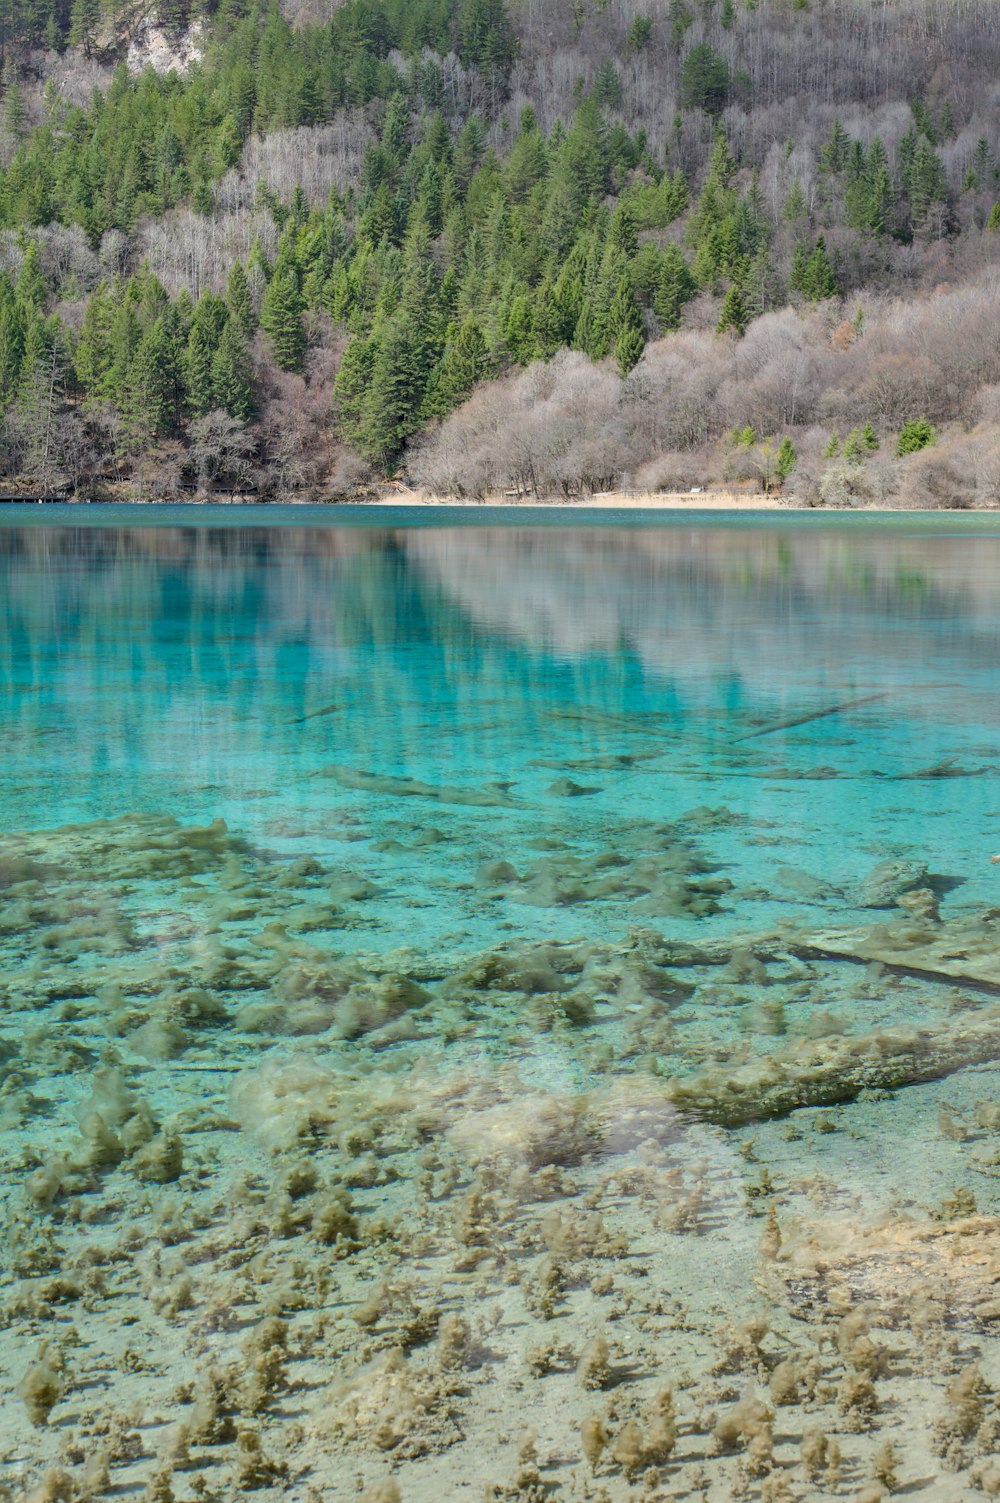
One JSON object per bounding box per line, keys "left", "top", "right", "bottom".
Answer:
{"left": 0, "top": 528, "right": 619, "bottom": 788}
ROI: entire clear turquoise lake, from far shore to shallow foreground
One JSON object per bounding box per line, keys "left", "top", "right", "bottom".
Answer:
{"left": 0, "top": 507, "right": 1000, "bottom": 1500}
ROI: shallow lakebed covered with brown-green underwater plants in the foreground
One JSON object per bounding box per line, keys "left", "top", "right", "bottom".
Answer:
{"left": 0, "top": 789, "right": 1000, "bottom": 1503}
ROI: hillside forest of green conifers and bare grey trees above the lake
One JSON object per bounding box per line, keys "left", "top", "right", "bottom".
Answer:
{"left": 0, "top": 0, "right": 1000, "bottom": 505}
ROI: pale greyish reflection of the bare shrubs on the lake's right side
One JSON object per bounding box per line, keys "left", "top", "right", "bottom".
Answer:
{"left": 408, "top": 528, "right": 1000, "bottom": 688}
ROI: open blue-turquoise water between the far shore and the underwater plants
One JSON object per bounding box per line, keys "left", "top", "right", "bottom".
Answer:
{"left": 0, "top": 510, "right": 1000, "bottom": 939}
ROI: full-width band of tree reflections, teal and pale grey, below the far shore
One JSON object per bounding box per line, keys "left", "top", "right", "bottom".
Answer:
{"left": 0, "top": 526, "right": 1000, "bottom": 799}
